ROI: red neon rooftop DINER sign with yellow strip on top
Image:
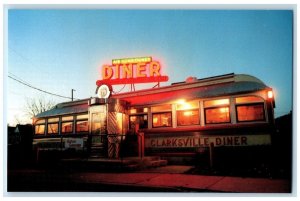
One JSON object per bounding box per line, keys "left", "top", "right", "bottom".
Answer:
{"left": 96, "top": 57, "right": 169, "bottom": 86}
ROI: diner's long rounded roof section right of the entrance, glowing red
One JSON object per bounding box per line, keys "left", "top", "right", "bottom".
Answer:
{"left": 113, "top": 73, "right": 269, "bottom": 106}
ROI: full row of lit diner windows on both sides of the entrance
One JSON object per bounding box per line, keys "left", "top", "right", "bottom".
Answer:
{"left": 35, "top": 96, "right": 265, "bottom": 135}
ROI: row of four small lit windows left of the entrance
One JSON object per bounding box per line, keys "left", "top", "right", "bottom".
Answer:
{"left": 35, "top": 114, "right": 89, "bottom": 135}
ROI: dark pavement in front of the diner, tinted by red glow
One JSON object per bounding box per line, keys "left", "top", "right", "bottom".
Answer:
{"left": 7, "top": 166, "right": 291, "bottom": 193}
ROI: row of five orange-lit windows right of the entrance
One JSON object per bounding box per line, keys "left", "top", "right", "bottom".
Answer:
{"left": 130, "top": 96, "right": 266, "bottom": 128}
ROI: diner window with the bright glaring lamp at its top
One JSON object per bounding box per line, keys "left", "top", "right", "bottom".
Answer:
{"left": 176, "top": 101, "right": 200, "bottom": 126}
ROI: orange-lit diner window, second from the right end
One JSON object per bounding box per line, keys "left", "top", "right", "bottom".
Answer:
{"left": 204, "top": 99, "right": 230, "bottom": 124}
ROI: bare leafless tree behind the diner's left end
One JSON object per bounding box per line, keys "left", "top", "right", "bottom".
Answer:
{"left": 25, "top": 97, "right": 56, "bottom": 118}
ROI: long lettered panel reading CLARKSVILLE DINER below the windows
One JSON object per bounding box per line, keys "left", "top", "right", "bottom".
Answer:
{"left": 145, "top": 135, "right": 271, "bottom": 148}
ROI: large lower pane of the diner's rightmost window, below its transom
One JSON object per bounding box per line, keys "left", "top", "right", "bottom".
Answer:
{"left": 236, "top": 103, "right": 265, "bottom": 122}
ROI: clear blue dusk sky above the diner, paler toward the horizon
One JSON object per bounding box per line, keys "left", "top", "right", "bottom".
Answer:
{"left": 4, "top": 9, "right": 293, "bottom": 123}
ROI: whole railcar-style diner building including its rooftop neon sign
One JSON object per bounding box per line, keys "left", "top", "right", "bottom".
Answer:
{"left": 33, "top": 57, "right": 275, "bottom": 163}
